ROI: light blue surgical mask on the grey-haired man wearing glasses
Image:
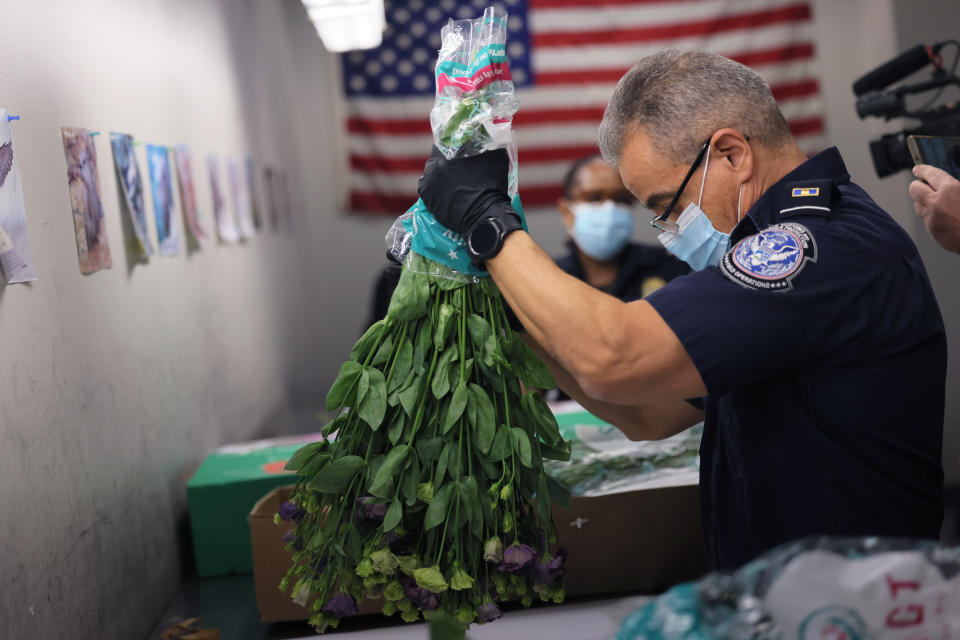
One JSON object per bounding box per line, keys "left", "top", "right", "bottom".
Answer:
{"left": 657, "top": 147, "right": 743, "bottom": 271}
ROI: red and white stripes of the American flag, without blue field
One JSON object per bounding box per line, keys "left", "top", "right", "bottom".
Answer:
{"left": 347, "top": 0, "right": 826, "bottom": 214}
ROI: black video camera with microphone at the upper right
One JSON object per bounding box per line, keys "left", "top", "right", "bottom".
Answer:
{"left": 853, "top": 40, "right": 960, "bottom": 178}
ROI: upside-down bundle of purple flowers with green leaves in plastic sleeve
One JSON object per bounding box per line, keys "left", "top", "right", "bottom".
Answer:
{"left": 277, "top": 9, "right": 570, "bottom": 632}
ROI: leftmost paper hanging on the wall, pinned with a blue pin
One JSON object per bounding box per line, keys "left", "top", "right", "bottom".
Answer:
{"left": 0, "top": 109, "right": 37, "bottom": 284}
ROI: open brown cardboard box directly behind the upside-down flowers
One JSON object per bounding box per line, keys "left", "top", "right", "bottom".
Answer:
{"left": 250, "top": 485, "right": 707, "bottom": 622}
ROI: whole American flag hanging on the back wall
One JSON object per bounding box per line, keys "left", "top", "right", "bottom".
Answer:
{"left": 343, "top": 0, "right": 826, "bottom": 215}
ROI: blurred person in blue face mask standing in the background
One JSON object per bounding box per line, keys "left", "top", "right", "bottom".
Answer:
{"left": 556, "top": 155, "right": 689, "bottom": 302}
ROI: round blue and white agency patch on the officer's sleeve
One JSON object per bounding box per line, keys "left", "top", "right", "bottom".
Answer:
{"left": 720, "top": 222, "right": 817, "bottom": 291}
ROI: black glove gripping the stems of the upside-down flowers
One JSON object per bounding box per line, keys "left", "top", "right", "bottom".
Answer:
{"left": 418, "top": 147, "right": 517, "bottom": 233}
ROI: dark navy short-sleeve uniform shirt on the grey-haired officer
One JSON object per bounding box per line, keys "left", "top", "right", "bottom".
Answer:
{"left": 647, "top": 148, "right": 946, "bottom": 569}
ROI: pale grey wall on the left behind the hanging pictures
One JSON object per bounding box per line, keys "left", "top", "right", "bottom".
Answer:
{"left": 0, "top": 0, "right": 344, "bottom": 640}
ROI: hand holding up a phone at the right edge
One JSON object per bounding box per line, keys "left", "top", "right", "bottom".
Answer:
{"left": 910, "top": 164, "right": 960, "bottom": 253}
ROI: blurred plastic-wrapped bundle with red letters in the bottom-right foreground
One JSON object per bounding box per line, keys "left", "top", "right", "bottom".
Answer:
{"left": 616, "top": 536, "right": 960, "bottom": 640}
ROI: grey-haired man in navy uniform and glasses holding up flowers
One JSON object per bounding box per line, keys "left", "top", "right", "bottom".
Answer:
{"left": 420, "top": 51, "right": 946, "bottom": 569}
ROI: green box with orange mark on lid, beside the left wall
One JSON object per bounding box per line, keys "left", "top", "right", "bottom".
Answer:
{"left": 187, "top": 433, "right": 330, "bottom": 578}
